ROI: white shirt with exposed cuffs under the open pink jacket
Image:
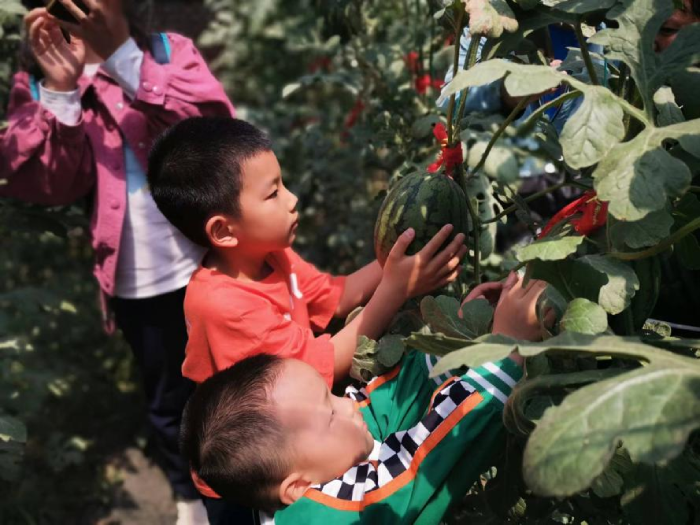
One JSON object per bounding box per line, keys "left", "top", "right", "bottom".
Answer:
{"left": 39, "top": 38, "right": 206, "bottom": 299}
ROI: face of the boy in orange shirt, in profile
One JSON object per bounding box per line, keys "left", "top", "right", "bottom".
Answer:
{"left": 235, "top": 151, "right": 298, "bottom": 254}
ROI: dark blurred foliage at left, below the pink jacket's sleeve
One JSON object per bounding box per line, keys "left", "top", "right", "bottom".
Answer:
{"left": 0, "top": 200, "right": 139, "bottom": 523}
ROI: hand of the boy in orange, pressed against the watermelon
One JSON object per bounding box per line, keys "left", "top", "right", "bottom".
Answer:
{"left": 380, "top": 224, "right": 467, "bottom": 299}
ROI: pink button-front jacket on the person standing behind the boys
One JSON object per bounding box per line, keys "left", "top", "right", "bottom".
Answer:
{"left": 0, "top": 34, "right": 234, "bottom": 296}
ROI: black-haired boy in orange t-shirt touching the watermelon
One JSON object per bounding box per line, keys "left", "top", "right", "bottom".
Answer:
{"left": 148, "top": 117, "right": 466, "bottom": 386}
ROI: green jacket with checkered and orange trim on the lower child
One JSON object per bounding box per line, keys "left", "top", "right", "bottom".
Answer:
{"left": 261, "top": 351, "right": 522, "bottom": 525}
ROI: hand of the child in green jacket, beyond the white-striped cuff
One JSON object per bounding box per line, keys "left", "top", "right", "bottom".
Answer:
{"left": 492, "top": 273, "right": 555, "bottom": 341}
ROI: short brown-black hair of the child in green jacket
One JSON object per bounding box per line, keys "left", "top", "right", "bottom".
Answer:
{"left": 180, "top": 354, "right": 289, "bottom": 511}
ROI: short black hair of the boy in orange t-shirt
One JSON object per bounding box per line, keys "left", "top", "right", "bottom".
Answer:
{"left": 148, "top": 117, "right": 272, "bottom": 246}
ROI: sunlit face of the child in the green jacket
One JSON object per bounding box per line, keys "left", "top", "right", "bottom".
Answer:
{"left": 271, "top": 359, "right": 374, "bottom": 498}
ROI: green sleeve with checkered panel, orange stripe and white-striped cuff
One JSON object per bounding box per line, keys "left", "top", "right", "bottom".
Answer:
{"left": 275, "top": 356, "right": 520, "bottom": 525}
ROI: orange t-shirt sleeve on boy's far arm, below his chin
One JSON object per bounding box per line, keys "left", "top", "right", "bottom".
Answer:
{"left": 290, "top": 250, "right": 345, "bottom": 331}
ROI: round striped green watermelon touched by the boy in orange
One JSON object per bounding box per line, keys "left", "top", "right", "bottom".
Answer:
{"left": 374, "top": 173, "right": 469, "bottom": 266}
